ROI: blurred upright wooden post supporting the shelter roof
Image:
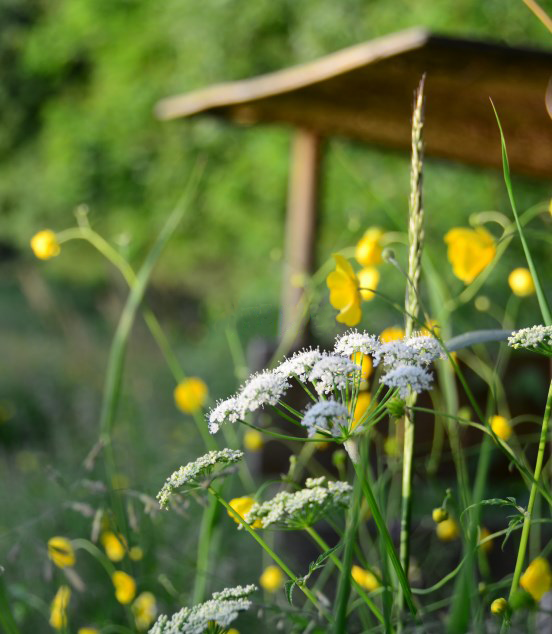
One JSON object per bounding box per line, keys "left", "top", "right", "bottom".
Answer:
{"left": 280, "top": 128, "right": 321, "bottom": 348}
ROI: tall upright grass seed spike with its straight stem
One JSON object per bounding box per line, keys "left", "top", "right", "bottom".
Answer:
{"left": 399, "top": 75, "right": 425, "bottom": 611}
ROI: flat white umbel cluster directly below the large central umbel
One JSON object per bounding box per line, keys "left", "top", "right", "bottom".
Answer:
{"left": 244, "top": 476, "right": 352, "bottom": 529}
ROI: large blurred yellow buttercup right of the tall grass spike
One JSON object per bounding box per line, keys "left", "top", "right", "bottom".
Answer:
{"left": 445, "top": 227, "right": 496, "bottom": 284}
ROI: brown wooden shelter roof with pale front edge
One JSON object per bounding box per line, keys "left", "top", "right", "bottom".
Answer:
{"left": 156, "top": 29, "right": 552, "bottom": 178}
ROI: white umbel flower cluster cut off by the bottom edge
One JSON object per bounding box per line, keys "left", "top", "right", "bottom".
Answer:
{"left": 149, "top": 584, "right": 257, "bottom": 634}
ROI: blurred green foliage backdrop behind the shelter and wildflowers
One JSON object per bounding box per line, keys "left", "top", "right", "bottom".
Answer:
{"left": 0, "top": 0, "right": 550, "bottom": 632}
